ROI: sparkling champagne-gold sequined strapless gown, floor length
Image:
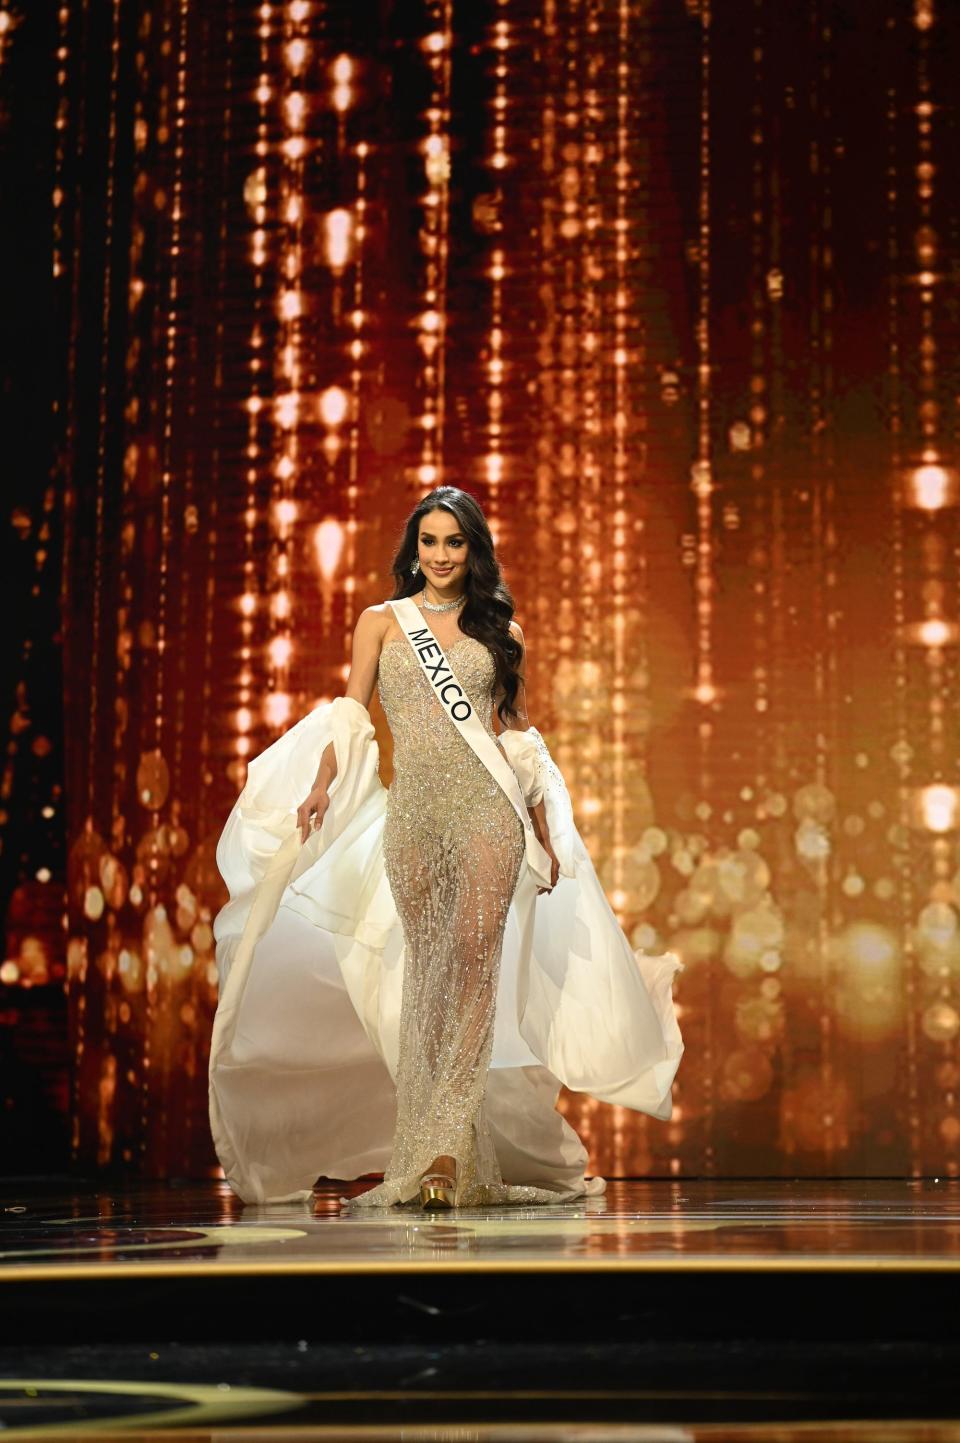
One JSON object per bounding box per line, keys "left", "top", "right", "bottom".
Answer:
{"left": 352, "top": 636, "right": 556, "bottom": 1208}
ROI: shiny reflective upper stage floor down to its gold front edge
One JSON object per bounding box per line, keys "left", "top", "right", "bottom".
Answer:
{"left": 0, "top": 1179, "right": 960, "bottom": 1281}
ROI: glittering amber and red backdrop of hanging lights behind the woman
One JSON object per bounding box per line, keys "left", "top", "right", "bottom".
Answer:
{"left": 0, "top": 0, "right": 960, "bottom": 1175}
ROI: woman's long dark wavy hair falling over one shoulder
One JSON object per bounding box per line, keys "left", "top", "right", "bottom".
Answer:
{"left": 391, "top": 486, "right": 523, "bottom": 722}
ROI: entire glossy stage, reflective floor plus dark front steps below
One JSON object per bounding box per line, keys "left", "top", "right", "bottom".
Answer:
{"left": 0, "top": 1179, "right": 960, "bottom": 1443}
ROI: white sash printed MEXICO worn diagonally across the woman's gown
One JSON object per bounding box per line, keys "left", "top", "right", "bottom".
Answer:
{"left": 390, "top": 596, "right": 551, "bottom": 887}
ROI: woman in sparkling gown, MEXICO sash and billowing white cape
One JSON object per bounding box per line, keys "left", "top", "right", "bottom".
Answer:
{"left": 211, "top": 486, "right": 683, "bottom": 1208}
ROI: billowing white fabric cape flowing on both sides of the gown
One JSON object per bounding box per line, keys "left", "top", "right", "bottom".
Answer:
{"left": 209, "top": 697, "right": 683, "bottom": 1202}
